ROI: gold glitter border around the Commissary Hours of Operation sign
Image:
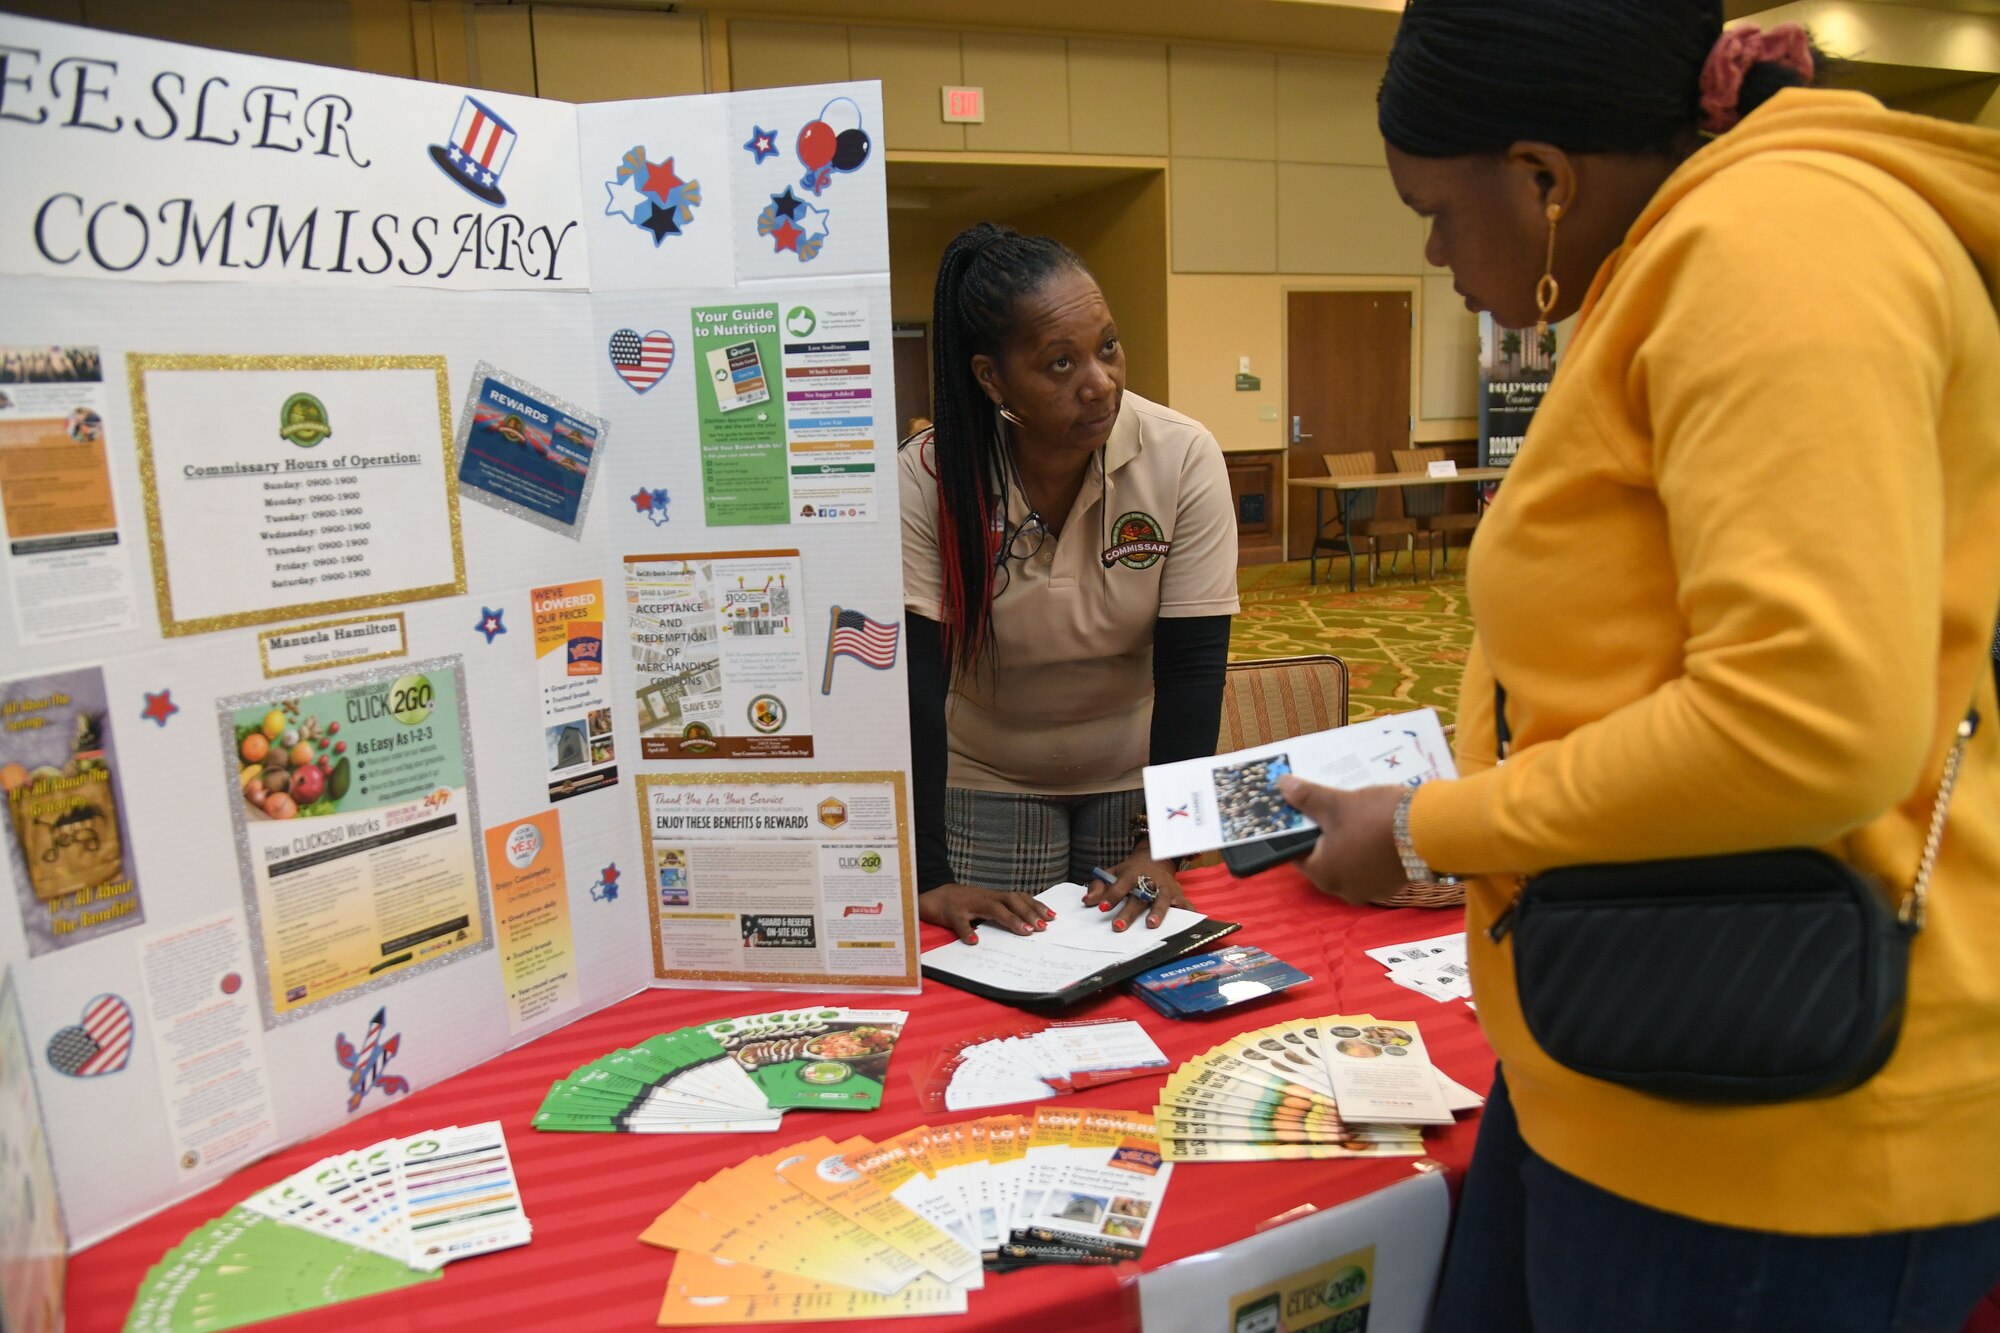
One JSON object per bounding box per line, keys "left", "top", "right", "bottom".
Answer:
{"left": 126, "top": 352, "right": 466, "bottom": 636}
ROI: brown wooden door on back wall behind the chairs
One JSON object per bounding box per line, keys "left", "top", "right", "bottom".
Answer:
{"left": 1284, "top": 292, "right": 1412, "bottom": 560}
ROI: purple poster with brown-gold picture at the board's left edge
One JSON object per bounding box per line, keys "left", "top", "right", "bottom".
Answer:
{"left": 0, "top": 667, "right": 146, "bottom": 957}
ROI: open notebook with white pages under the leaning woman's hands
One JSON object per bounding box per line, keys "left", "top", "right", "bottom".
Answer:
{"left": 924, "top": 885, "right": 1240, "bottom": 1005}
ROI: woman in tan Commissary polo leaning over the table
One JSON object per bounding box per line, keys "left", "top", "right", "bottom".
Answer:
{"left": 900, "top": 224, "right": 1236, "bottom": 943}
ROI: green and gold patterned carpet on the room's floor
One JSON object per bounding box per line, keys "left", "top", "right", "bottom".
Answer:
{"left": 1230, "top": 550, "right": 1472, "bottom": 723}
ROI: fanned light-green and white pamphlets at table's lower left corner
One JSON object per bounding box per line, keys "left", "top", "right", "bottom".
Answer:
{"left": 124, "top": 1121, "right": 534, "bottom": 1333}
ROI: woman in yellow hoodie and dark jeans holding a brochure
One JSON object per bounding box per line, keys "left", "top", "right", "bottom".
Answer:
{"left": 1288, "top": 0, "right": 2000, "bottom": 1333}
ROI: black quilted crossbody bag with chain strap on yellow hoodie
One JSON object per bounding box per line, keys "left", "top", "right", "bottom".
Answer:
{"left": 1488, "top": 685, "right": 1980, "bottom": 1103}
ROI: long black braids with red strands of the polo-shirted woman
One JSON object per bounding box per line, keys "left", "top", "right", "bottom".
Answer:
{"left": 918, "top": 222, "right": 1088, "bottom": 681}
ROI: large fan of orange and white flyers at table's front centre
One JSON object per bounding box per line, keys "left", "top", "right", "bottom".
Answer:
{"left": 640, "top": 1107, "right": 1172, "bottom": 1327}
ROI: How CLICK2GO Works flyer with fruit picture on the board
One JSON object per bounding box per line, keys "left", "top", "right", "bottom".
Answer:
{"left": 218, "top": 656, "right": 492, "bottom": 1027}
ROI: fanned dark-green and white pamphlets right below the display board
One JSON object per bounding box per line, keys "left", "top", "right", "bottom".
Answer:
{"left": 534, "top": 1009, "right": 910, "bottom": 1135}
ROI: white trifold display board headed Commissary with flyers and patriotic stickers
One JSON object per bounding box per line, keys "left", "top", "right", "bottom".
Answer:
{"left": 0, "top": 16, "right": 918, "bottom": 1245}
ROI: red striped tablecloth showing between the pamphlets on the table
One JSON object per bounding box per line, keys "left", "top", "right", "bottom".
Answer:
{"left": 68, "top": 867, "right": 1492, "bottom": 1333}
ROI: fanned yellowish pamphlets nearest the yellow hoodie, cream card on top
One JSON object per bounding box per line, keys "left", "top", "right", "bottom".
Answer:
{"left": 1154, "top": 1015, "right": 1480, "bottom": 1161}
